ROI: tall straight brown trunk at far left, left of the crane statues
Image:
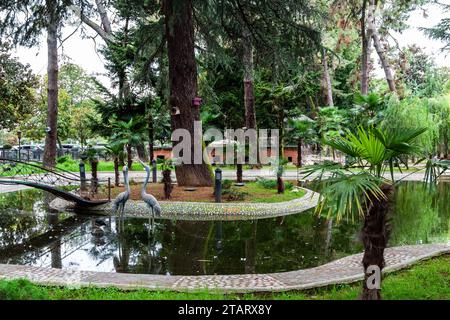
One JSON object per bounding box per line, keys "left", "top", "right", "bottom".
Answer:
{"left": 43, "top": 0, "right": 58, "bottom": 167}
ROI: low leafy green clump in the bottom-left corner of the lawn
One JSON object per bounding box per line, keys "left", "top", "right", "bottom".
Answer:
{"left": 0, "top": 279, "right": 49, "bottom": 300}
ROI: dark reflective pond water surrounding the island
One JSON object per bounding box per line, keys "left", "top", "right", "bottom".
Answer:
{"left": 0, "top": 182, "right": 450, "bottom": 275}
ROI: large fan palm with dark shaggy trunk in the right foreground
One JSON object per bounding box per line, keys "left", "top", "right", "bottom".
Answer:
{"left": 302, "top": 127, "right": 430, "bottom": 300}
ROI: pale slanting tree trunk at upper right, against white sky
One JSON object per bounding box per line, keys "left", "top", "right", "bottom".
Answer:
{"left": 367, "top": 0, "right": 396, "bottom": 92}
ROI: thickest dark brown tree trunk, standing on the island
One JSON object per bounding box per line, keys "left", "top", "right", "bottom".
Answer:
{"left": 163, "top": 0, "right": 213, "bottom": 186}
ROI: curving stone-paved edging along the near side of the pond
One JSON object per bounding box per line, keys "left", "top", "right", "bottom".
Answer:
{"left": 0, "top": 244, "right": 450, "bottom": 292}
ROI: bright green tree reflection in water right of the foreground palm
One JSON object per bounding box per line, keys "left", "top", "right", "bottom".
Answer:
{"left": 389, "top": 182, "right": 450, "bottom": 246}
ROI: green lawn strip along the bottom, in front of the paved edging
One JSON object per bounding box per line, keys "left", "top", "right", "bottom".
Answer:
{"left": 0, "top": 254, "right": 450, "bottom": 300}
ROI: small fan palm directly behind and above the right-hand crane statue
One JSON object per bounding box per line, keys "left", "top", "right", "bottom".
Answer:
{"left": 112, "top": 117, "right": 146, "bottom": 170}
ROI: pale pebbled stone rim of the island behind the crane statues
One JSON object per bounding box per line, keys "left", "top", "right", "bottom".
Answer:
{"left": 50, "top": 188, "right": 320, "bottom": 221}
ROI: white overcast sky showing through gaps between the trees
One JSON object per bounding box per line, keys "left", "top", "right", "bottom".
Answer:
{"left": 10, "top": 0, "right": 450, "bottom": 87}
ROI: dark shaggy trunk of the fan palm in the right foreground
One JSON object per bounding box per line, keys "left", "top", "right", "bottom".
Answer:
{"left": 361, "top": 184, "right": 394, "bottom": 300}
